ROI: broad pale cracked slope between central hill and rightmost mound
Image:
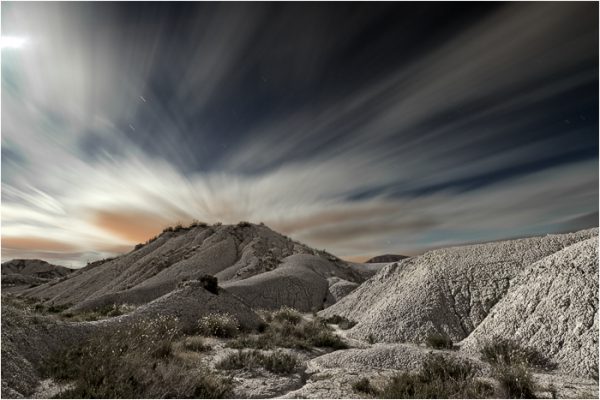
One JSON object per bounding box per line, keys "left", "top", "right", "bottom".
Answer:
{"left": 319, "top": 228, "right": 598, "bottom": 342}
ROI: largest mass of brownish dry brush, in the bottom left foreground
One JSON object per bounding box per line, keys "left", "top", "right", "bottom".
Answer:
{"left": 41, "top": 316, "right": 231, "bottom": 398}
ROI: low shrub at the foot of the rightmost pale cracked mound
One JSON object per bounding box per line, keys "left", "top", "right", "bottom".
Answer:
{"left": 480, "top": 337, "right": 556, "bottom": 369}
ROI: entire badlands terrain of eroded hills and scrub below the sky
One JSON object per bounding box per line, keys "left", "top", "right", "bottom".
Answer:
{"left": 2, "top": 222, "right": 598, "bottom": 398}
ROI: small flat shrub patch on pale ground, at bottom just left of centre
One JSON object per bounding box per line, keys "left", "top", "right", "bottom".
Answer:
{"left": 215, "top": 350, "right": 298, "bottom": 374}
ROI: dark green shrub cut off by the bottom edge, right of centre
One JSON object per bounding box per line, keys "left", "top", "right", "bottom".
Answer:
{"left": 378, "top": 355, "right": 494, "bottom": 398}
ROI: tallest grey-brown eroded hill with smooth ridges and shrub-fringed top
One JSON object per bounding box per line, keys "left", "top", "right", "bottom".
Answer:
{"left": 24, "top": 223, "right": 364, "bottom": 310}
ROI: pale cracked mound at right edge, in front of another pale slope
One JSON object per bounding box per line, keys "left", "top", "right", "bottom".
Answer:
{"left": 463, "top": 237, "right": 598, "bottom": 376}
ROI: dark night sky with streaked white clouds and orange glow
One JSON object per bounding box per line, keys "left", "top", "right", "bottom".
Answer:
{"left": 1, "top": 2, "right": 599, "bottom": 267}
